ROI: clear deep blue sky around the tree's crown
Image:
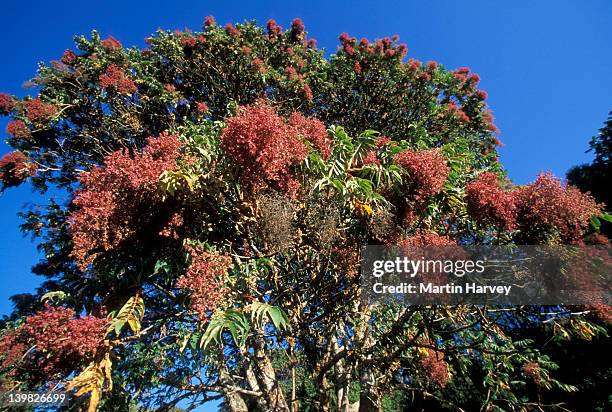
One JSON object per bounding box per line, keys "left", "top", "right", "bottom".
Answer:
{"left": 0, "top": 0, "right": 612, "bottom": 320}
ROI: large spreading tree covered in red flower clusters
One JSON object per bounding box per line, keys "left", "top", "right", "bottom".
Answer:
{"left": 0, "top": 17, "right": 609, "bottom": 411}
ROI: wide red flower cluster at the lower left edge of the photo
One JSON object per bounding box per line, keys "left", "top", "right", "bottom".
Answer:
{"left": 0, "top": 307, "right": 108, "bottom": 379}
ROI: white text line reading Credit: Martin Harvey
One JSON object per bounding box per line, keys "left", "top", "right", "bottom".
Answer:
{"left": 372, "top": 282, "right": 512, "bottom": 296}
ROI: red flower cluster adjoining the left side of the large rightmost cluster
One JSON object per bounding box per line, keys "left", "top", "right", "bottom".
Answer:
{"left": 465, "top": 172, "right": 516, "bottom": 230}
